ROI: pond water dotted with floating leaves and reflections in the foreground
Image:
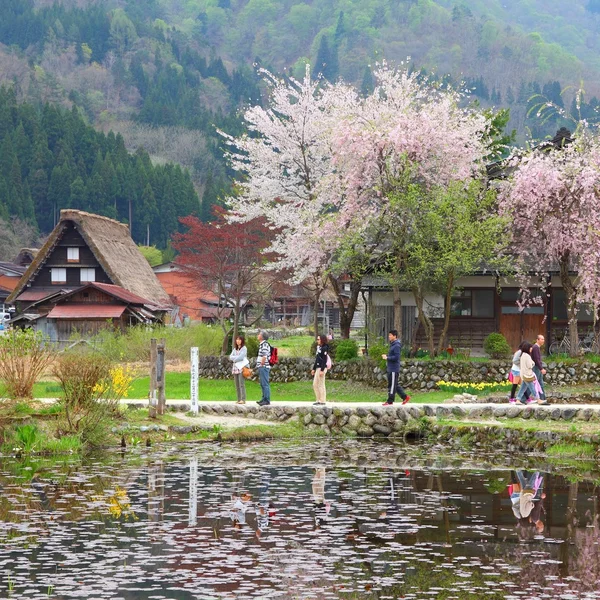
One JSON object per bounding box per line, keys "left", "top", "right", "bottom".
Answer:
{"left": 0, "top": 441, "right": 600, "bottom": 600}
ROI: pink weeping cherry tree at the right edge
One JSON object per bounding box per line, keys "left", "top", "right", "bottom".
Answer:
{"left": 500, "top": 127, "right": 600, "bottom": 355}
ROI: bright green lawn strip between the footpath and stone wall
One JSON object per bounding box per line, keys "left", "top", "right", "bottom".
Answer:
{"left": 34, "top": 373, "right": 452, "bottom": 402}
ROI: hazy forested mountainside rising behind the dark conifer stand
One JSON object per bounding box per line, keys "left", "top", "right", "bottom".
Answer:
{"left": 0, "top": 0, "right": 600, "bottom": 246}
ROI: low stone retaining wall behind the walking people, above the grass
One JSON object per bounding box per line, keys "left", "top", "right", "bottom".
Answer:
{"left": 200, "top": 356, "right": 600, "bottom": 390}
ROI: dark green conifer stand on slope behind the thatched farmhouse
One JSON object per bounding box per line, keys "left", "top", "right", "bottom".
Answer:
{"left": 0, "top": 89, "right": 199, "bottom": 247}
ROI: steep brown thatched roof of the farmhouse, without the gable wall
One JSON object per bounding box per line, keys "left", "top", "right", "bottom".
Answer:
{"left": 8, "top": 209, "right": 171, "bottom": 306}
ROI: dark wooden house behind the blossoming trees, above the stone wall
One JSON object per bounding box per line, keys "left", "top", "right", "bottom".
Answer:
{"left": 363, "top": 272, "right": 594, "bottom": 351}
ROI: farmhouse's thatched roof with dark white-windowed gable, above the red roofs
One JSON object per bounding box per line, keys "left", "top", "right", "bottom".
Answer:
{"left": 7, "top": 210, "right": 171, "bottom": 308}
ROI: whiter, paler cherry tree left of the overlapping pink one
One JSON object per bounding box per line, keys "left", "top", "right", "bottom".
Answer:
{"left": 221, "top": 67, "right": 360, "bottom": 337}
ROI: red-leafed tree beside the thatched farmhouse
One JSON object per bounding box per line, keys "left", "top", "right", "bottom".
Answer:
{"left": 173, "top": 208, "right": 274, "bottom": 353}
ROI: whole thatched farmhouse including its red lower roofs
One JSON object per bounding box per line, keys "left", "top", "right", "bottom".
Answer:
{"left": 7, "top": 210, "right": 171, "bottom": 343}
